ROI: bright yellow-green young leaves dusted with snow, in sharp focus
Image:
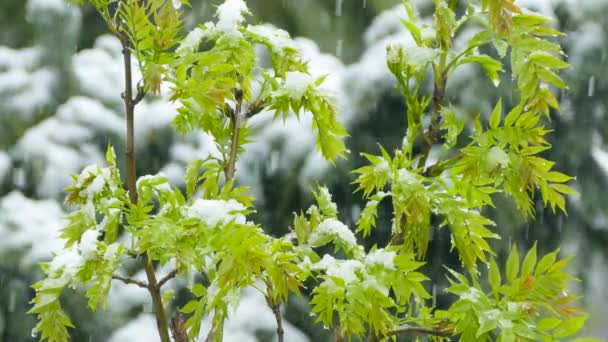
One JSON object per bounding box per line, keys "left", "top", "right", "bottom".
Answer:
{"left": 30, "top": 0, "right": 587, "bottom": 342}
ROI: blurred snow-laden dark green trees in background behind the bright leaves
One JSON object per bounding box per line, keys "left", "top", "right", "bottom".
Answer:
{"left": 0, "top": 0, "right": 608, "bottom": 341}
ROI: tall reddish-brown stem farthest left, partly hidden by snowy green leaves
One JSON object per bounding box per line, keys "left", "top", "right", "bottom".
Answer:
{"left": 121, "top": 42, "right": 171, "bottom": 342}
